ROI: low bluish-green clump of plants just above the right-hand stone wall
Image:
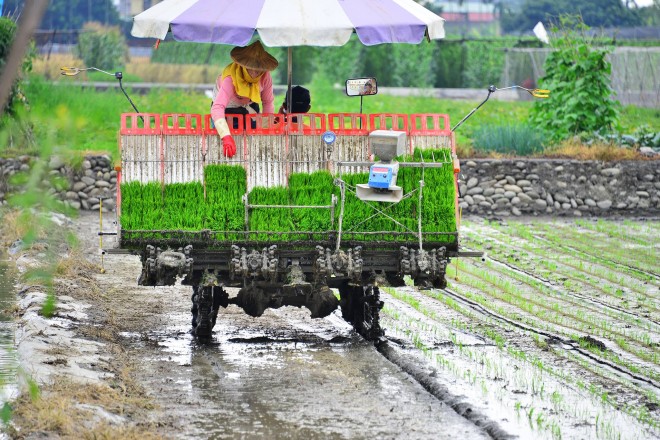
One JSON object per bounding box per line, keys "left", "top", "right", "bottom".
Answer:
{"left": 474, "top": 124, "right": 543, "bottom": 156}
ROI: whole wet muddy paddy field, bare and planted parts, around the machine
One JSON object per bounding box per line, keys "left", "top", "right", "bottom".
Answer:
{"left": 11, "top": 214, "right": 660, "bottom": 439}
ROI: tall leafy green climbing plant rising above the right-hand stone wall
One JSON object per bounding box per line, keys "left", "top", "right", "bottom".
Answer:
{"left": 530, "top": 16, "right": 620, "bottom": 141}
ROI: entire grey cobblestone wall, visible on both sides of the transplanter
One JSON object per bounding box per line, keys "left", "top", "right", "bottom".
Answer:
{"left": 0, "top": 156, "right": 660, "bottom": 216}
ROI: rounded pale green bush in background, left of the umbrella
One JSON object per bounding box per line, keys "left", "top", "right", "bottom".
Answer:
{"left": 75, "top": 22, "right": 128, "bottom": 72}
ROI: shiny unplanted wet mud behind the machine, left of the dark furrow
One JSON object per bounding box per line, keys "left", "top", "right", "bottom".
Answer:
{"left": 126, "top": 292, "right": 488, "bottom": 439}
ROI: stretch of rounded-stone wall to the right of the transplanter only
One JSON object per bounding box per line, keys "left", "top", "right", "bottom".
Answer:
{"left": 459, "top": 159, "right": 660, "bottom": 217}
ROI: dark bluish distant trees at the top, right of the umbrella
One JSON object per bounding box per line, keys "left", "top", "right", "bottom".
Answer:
{"left": 502, "top": 0, "right": 642, "bottom": 32}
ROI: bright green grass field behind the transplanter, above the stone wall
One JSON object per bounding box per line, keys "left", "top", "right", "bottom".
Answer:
{"left": 20, "top": 75, "right": 660, "bottom": 159}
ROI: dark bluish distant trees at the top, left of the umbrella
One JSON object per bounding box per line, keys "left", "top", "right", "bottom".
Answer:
{"left": 2, "top": 0, "right": 120, "bottom": 30}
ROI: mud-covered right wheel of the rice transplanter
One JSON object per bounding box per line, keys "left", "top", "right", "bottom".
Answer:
{"left": 339, "top": 284, "right": 385, "bottom": 341}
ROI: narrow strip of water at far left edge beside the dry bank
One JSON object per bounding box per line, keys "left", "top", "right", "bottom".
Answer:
{"left": 0, "top": 262, "right": 18, "bottom": 408}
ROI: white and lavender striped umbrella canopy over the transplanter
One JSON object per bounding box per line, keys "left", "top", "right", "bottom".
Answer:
{"left": 131, "top": 0, "right": 445, "bottom": 47}
